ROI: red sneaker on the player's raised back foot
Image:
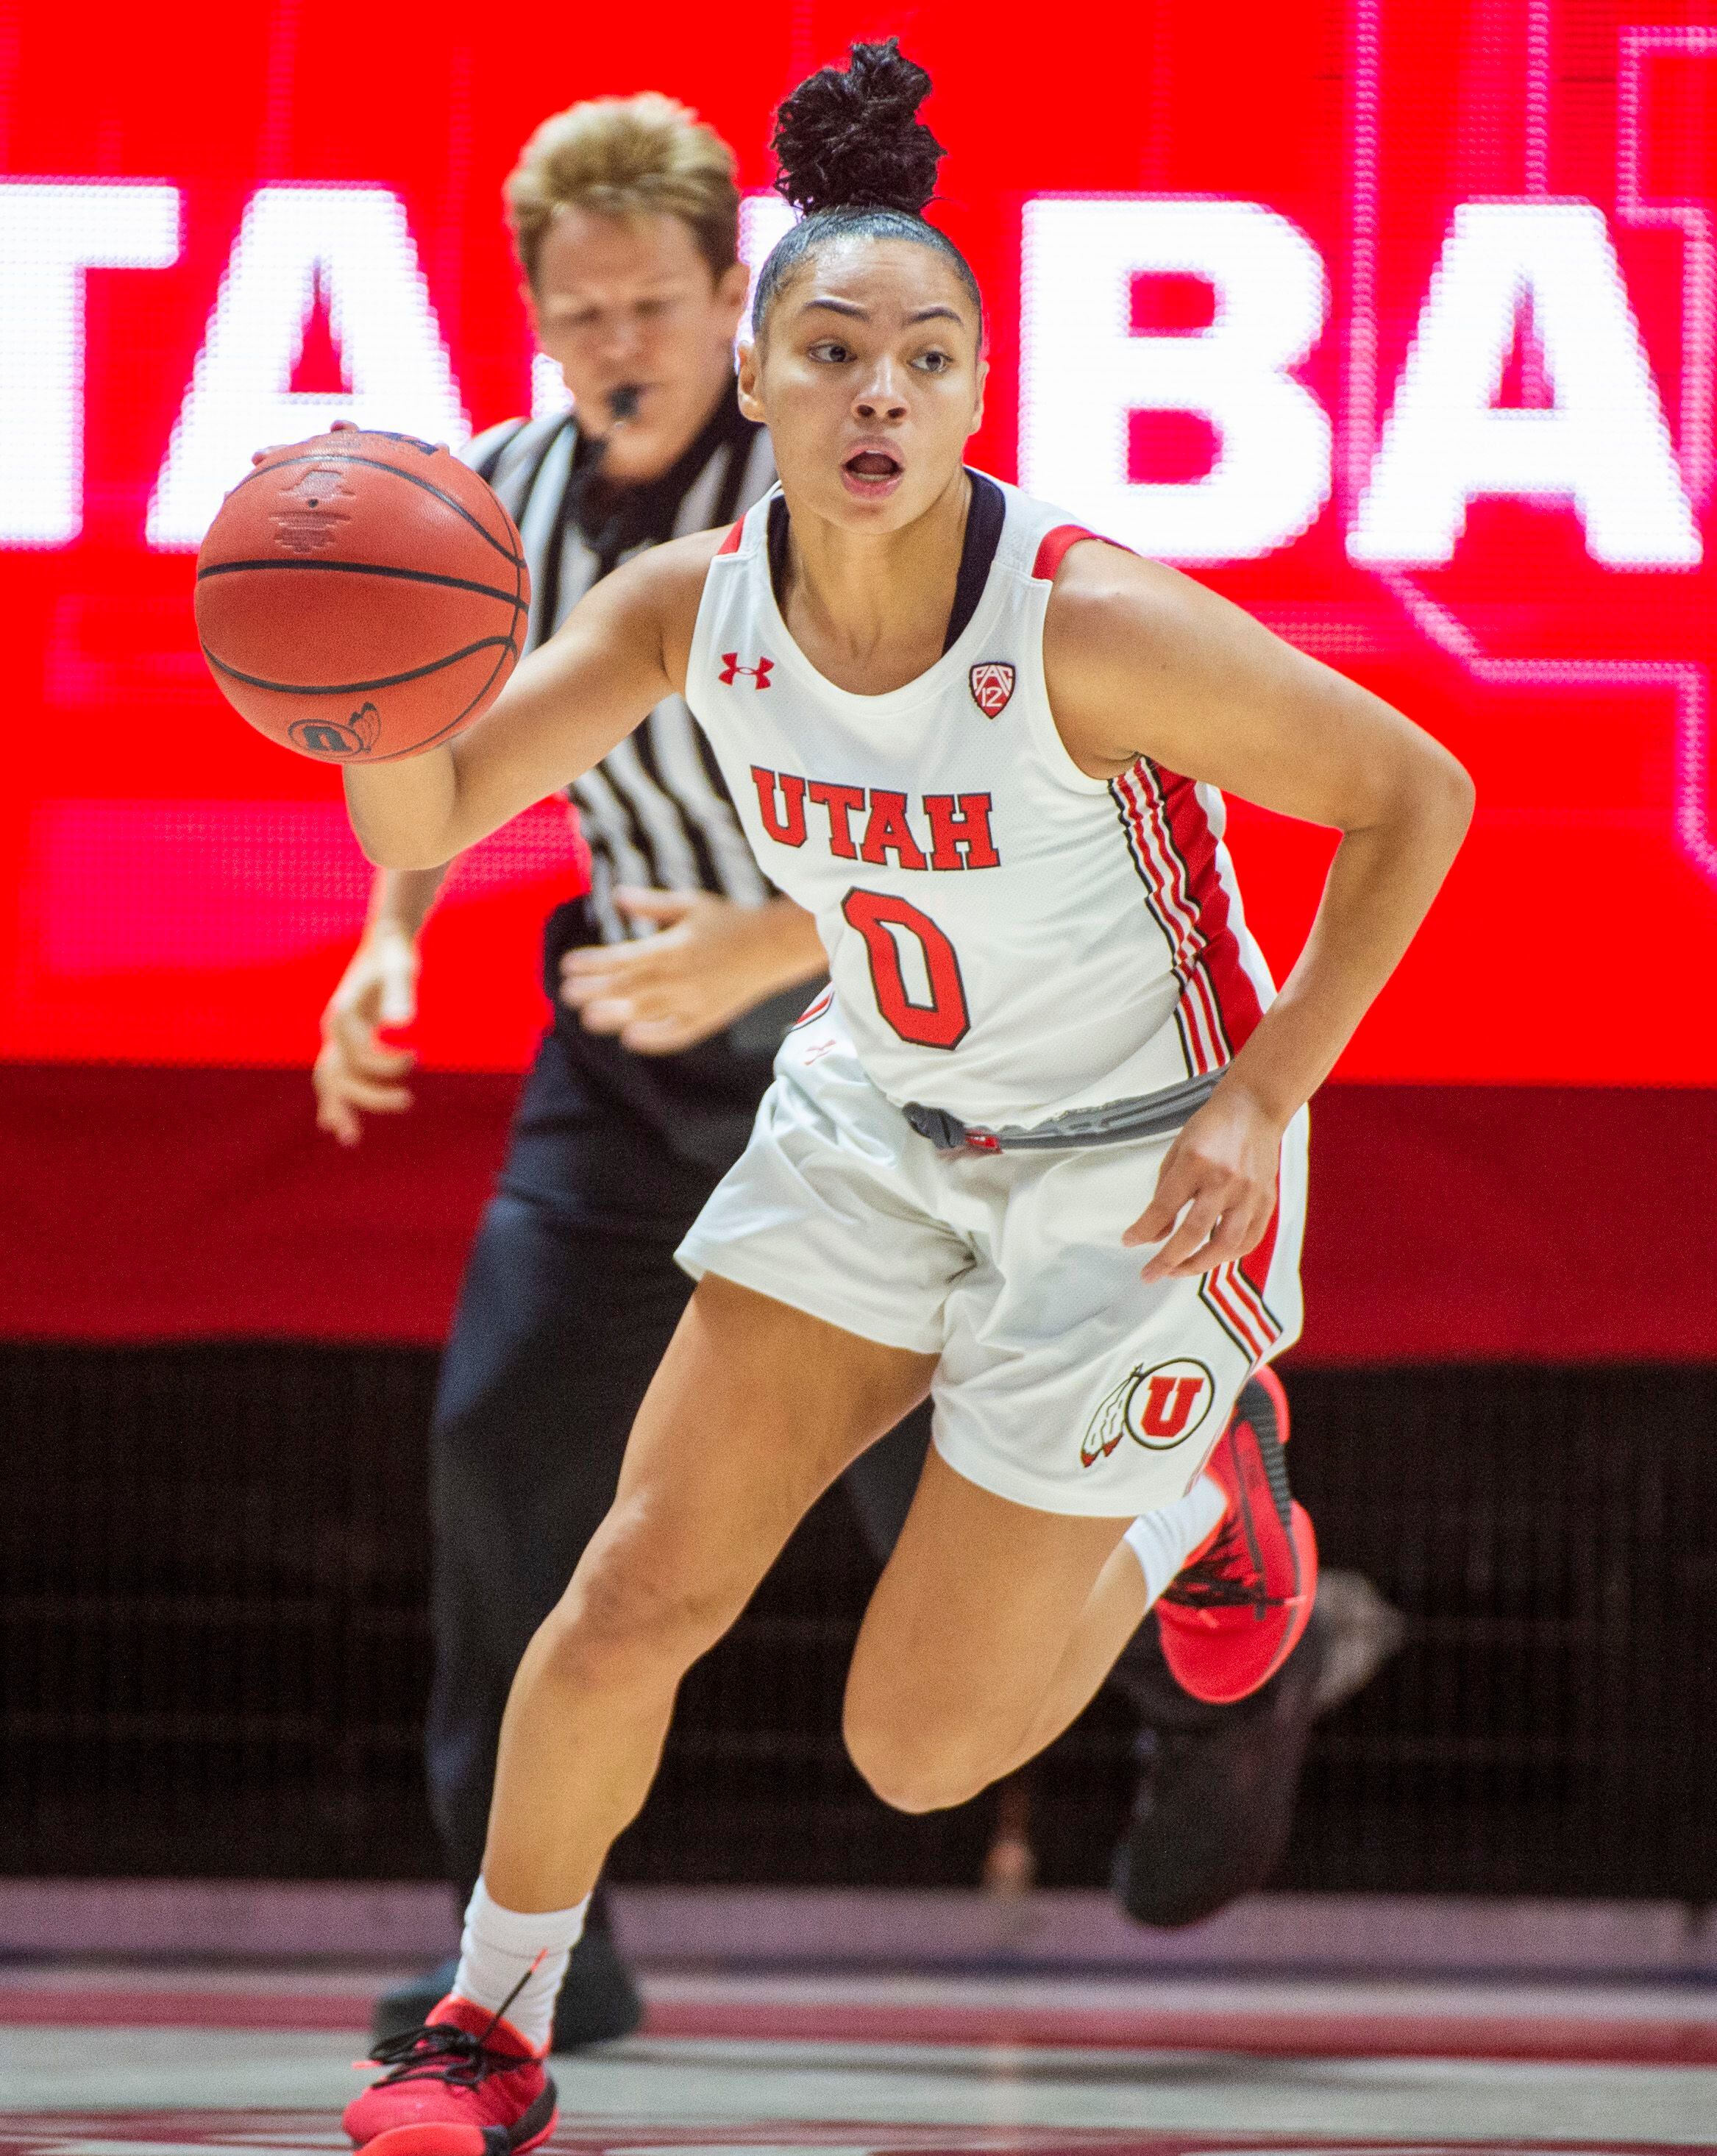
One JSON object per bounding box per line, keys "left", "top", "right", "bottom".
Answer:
{"left": 1157, "top": 1365, "right": 1318, "bottom": 1706}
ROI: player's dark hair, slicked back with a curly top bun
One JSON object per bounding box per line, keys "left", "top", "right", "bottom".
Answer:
{"left": 752, "top": 37, "right": 984, "bottom": 332}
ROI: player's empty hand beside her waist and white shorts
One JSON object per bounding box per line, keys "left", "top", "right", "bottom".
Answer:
{"left": 1120, "top": 1080, "right": 1284, "bottom": 1280}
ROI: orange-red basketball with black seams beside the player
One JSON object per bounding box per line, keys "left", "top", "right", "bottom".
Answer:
{"left": 196, "top": 429, "right": 530, "bottom": 763}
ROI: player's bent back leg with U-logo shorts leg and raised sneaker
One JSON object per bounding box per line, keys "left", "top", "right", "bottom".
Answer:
{"left": 847, "top": 1132, "right": 1316, "bottom": 1809}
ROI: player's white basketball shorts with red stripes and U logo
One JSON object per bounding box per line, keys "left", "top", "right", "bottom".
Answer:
{"left": 677, "top": 1004, "right": 1306, "bottom": 1518}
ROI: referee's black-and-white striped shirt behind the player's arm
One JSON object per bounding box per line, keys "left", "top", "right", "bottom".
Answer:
{"left": 463, "top": 390, "right": 775, "bottom": 942}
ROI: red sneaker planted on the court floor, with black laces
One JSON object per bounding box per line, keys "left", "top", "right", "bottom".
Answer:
{"left": 343, "top": 1994, "right": 558, "bottom": 2156}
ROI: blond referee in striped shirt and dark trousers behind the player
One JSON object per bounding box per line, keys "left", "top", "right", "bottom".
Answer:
{"left": 315, "top": 95, "right": 1325, "bottom": 2050}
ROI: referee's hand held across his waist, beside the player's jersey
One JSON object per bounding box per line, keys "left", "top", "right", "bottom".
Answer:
{"left": 560, "top": 886, "right": 801, "bottom": 1057}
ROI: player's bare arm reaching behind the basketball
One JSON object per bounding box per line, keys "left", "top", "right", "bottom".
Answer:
{"left": 345, "top": 533, "right": 722, "bottom": 869}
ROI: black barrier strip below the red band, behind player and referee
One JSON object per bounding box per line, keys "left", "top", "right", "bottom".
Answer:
{"left": 0, "top": 1343, "right": 1717, "bottom": 1899}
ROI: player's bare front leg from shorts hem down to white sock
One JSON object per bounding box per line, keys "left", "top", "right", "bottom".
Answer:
{"left": 485, "top": 1277, "right": 933, "bottom": 1910}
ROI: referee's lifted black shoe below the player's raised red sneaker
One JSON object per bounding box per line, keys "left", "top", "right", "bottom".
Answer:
{"left": 1114, "top": 1609, "right": 1329, "bottom": 1929}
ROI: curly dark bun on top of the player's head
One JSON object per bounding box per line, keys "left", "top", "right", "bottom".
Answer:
{"left": 773, "top": 39, "right": 942, "bottom": 216}
